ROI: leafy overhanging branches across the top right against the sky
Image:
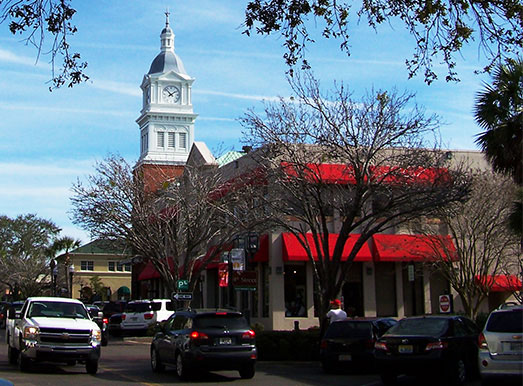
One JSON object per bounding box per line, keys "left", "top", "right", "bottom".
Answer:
{"left": 244, "top": 0, "right": 523, "bottom": 83}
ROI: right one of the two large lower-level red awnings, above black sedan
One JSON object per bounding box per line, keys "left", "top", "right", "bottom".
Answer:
{"left": 372, "top": 234, "right": 458, "bottom": 262}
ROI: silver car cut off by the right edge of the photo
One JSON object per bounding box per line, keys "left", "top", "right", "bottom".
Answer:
{"left": 478, "top": 305, "right": 523, "bottom": 384}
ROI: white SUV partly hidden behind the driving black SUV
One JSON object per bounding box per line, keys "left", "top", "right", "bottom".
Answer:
{"left": 120, "top": 299, "right": 174, "bottom": 333}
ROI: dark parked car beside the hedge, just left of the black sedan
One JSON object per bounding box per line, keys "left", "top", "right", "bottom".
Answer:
{"left": 320, "top": 318, "right": 397, "bottom": 373}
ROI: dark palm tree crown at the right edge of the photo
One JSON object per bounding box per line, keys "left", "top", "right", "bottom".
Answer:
{"left": 474, "top": 58, "right": 523, "bottom": 185}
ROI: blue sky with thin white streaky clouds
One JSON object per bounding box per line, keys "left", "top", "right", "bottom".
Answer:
{"left": 0, "top": 0, "right": 489, "bottom": 242}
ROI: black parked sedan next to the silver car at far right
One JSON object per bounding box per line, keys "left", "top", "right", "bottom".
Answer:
{"left": 374, "top": 315, "right": 479, "bottom": 385}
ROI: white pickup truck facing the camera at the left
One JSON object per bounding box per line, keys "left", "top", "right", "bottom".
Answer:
{"left": 6, "top": 297, "right": 102, "bottom": 374}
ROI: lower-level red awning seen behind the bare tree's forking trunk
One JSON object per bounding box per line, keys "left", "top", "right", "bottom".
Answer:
{"left": 282, "top": 233, "right": 372, "bottom": 261}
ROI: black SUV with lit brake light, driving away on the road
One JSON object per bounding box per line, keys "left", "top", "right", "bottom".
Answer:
{"left": 151, "top": 310, "right": 258, "bottom": 379}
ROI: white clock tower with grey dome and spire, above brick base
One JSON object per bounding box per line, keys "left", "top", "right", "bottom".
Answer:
{"left": 136, "top": 12, "right": 197, "bottom": 170}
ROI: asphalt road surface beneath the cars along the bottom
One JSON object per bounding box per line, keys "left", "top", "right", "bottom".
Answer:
{"left": 0, "top": 330, "right": 496, "bottom": 386}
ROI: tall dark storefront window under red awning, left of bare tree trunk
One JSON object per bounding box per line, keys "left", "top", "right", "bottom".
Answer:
{"left": 284, "top": 265, "right": 307, "bottom": 317}
